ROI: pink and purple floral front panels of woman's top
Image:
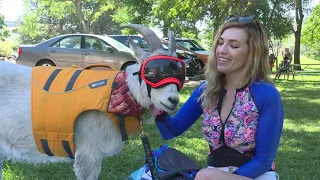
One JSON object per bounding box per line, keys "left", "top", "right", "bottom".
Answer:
{"left": 202, "top": 87, "right": 259, "bottom": 153}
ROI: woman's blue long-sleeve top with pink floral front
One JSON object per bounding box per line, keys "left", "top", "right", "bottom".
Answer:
{"left": 156, "top": 81, "right": 284, "bottom": 179}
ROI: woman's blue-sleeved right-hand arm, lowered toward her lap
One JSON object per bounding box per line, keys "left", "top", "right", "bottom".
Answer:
{"left": 236, "top": 89, "right": 284, "bottom": 179}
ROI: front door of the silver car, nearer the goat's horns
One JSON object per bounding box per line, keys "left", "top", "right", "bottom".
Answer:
{"left": 83, "top": 36, "right": 119, "bottom": 67}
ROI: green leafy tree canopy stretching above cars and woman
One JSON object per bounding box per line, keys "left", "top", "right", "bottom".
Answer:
{"left": 19, "top": 0, "right": 312, "bottom": 59}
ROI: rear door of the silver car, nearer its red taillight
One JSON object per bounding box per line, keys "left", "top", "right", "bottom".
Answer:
{"left": 48, "top": 35, "right": 83, "bottom": 67}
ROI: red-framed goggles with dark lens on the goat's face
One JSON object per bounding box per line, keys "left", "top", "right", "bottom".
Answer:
{"left": 141, "top": 56, "right": 186, "bottom": 91}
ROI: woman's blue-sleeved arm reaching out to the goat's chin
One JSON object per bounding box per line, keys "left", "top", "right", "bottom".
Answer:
{"left": 156, "top": 83, "right": 203, "bottom": 139}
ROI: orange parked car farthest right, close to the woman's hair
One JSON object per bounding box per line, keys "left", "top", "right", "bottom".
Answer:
{"left": 164, "top": 38, "right": 210, "bottom": 64}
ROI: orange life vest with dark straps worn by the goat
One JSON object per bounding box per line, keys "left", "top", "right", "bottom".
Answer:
{"left": 31, "top": 66, "right": 140, "bottom": 158}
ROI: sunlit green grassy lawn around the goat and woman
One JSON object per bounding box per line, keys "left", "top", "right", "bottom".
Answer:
{"left": 4, "top": 58, "right": 320, "bottom": 180}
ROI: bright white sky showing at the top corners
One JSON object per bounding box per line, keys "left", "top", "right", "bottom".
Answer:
{"left": 0, "top": 0, "right": 320, "bottom": 21}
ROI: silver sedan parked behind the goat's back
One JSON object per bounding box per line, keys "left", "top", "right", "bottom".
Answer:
{"left": 16, "top": 34, "right": 136, "bottom": 69}
